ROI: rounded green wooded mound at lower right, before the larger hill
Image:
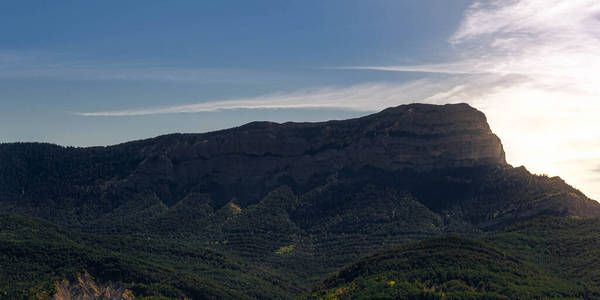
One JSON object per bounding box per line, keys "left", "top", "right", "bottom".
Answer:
{"left": 307, "top": 237, "right": 584, "bottom": 299}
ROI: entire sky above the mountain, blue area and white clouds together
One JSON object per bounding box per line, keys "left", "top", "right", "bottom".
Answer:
{"left": 0, "top": 0, "right": 600, "bottom": 199}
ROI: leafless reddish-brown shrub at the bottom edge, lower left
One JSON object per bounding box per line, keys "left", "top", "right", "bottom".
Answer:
{"left": 53, "top": 272, "right": 134, "bottom": 300}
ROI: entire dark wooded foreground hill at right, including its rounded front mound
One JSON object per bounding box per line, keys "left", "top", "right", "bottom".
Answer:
{"left": 306, "top": 217, "right": 600, "bottom": 299}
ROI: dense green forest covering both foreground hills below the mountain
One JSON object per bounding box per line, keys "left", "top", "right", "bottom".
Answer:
{"left": 5, "top": 215, "right": 600, "bottom": 299}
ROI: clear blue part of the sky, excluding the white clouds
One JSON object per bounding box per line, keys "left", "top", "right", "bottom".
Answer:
{"left": 0, "top": 0, "right": 467, "bottom": 145}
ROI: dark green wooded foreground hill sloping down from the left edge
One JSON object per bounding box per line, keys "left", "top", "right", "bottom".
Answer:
{"left": 0, "top": 215, "right": 297, "bottom": 299}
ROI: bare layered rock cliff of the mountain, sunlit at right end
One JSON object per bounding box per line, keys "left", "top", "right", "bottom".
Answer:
{"left": 129, "top": 104, "right": 507, "bottom": 205}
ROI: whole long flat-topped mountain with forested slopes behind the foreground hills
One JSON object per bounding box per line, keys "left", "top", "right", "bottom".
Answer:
{"left": 0, "top": 104, "right": 600, "bottom": 298}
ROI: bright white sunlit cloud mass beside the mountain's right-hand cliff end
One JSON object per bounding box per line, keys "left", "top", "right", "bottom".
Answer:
{"left": 355, "top": 0, "right": 600, "bottom": 199}
